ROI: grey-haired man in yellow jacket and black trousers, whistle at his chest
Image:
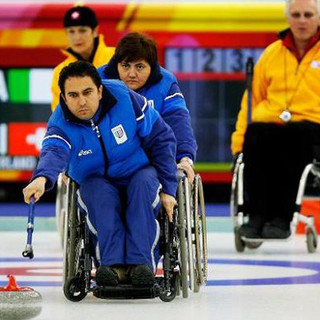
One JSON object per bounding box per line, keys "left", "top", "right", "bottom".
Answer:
{"left": 231, "top": 0, "right": 320, "bottom": 238}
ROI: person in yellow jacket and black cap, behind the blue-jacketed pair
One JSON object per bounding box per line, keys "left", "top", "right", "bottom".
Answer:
{"left": 51, "top": 6, "right": 114, "bottom": 111}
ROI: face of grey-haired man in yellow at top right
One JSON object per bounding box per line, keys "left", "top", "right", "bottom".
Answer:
{"left": 288, "top": 0, "right": 319, "bottom": 41}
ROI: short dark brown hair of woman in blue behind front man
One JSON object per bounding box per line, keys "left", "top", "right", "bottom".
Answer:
{"left": 114, "top": 32, "right": 158, "bottom": 67}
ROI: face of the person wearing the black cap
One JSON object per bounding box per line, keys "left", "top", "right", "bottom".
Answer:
{"left": 66, "top": 26, "right": 97, "bottom": 55}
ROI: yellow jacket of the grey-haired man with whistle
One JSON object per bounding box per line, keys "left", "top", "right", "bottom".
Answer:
{"left": 231, "top": 30, "right": 320, "bottom": 154}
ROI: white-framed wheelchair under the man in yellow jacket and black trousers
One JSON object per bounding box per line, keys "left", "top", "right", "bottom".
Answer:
{"left": 230, "top": 154, "right": 320, "bottom": 253}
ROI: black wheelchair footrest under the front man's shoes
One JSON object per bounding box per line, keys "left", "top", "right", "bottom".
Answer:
{"left": 93, "top": 285, "right": 160, "bottom": 299}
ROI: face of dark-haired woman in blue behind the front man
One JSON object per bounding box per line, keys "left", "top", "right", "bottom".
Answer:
{"left": 118, "top": 59, "right": 151, "bottom": 90}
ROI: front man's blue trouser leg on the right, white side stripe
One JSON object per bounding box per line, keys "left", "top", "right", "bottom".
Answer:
{"left": 126, "top": 166, "right": 160, "bottom": 284}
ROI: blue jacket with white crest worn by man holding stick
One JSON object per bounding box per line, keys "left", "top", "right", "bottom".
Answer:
{"left": 32, "top": 80, "right": 177, "bottom": 196}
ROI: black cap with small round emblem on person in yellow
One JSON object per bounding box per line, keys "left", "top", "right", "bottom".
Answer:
{"left": 63, "top": 6, "right": 98, "bottom": 29}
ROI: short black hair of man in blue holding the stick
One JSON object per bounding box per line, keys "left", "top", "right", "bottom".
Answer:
{"left": 59, "top": 60, "right": 101, "bottom": 95}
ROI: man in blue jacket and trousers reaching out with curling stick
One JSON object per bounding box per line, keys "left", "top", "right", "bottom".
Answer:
{"left": 23, "top": 61, "right": 177, "bottom": 286}
